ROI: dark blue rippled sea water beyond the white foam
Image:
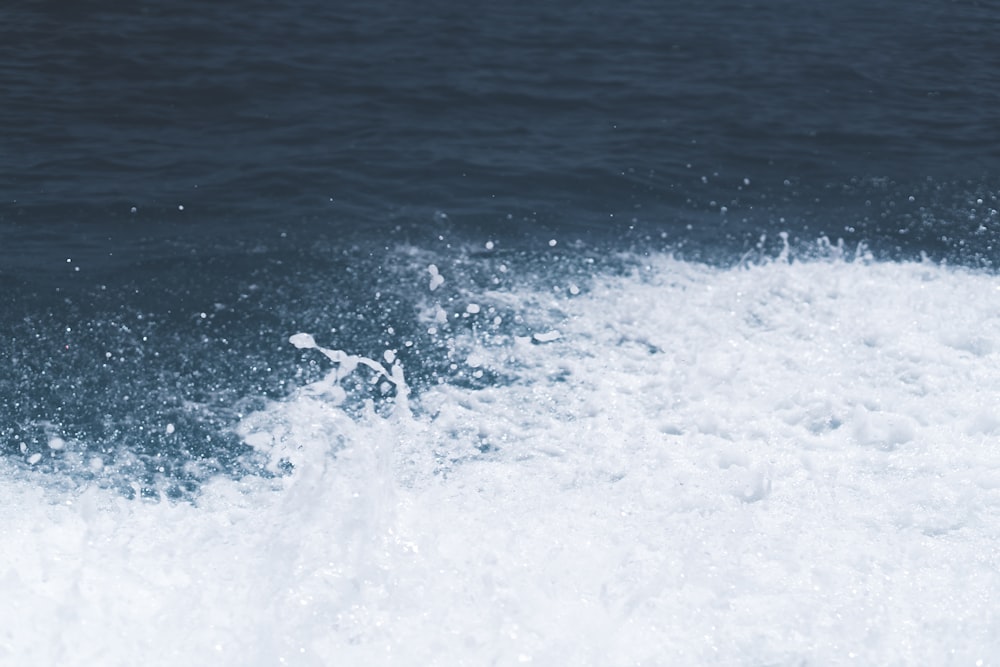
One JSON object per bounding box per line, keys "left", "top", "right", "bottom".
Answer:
{"left": 0, "top": 0, "right": 1000, "bottom": 490}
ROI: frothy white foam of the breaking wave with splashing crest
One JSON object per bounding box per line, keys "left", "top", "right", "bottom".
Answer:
{"left": 0, "top": 253, "right": 1000, "bottom": 665}
